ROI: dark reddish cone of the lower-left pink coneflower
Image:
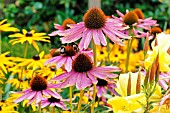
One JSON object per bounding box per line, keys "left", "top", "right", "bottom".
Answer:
{"left": 30, "top": 75, "right": 47, "bottom": 91}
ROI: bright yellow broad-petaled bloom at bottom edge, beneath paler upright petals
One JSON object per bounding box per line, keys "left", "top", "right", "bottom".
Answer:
{"left": 107, "top": 93, "right": 146, "bottom": 113}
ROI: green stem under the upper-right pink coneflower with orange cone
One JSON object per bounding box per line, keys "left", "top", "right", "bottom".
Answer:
{"left": 125, "top": 37, "right": 133, "bottom": 73}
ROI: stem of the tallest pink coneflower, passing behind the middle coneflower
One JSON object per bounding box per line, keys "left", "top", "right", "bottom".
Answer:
{"left": 91, "top": 40, "right": 97, "bottom": 113}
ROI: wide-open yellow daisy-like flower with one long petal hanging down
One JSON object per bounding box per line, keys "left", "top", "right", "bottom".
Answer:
{"left": 9, "top": 29, "right": 50, "bottom": 52}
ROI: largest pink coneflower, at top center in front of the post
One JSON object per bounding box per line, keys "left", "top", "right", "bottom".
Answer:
{"left": 61, "top": 8, "right": 130, "bottom": 50}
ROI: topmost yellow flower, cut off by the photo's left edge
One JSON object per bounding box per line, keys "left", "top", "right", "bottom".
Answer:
{"left": 0, "top": 19, "right": 19, "bottom": 32}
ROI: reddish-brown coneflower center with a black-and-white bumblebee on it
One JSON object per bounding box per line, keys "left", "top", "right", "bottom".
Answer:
{"left": 60, "top": 46, "right": 76, "bottom": 56}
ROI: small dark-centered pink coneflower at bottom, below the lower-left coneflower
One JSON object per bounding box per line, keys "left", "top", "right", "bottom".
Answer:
{"left": 41, "top": 97, "right": 67, "bottom": 110}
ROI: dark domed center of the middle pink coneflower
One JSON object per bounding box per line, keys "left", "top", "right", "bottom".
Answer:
{"left": 73, "top": 53, "right": 93, "bottom": 72}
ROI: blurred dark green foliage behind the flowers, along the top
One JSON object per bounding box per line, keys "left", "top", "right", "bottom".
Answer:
{"left": 0, "top": 0, "right": 170, "bottom": 57}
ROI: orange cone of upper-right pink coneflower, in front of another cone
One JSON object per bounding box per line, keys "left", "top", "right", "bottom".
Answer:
{"left": 123, "top": 11, "right": 138, "bottom": 25}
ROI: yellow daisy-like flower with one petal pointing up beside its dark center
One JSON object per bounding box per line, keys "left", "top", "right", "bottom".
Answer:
{"left": 16, "top": 51, "right": 47, "bottom": 70}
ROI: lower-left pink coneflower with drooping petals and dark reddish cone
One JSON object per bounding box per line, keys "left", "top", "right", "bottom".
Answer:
{"left": 15, "top": 75, "right": 61, "bottom": 104}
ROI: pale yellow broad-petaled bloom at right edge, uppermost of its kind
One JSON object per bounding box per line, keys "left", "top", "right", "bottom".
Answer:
{"left": 144, "top": 33, "right": 170, "bottom": 72}
